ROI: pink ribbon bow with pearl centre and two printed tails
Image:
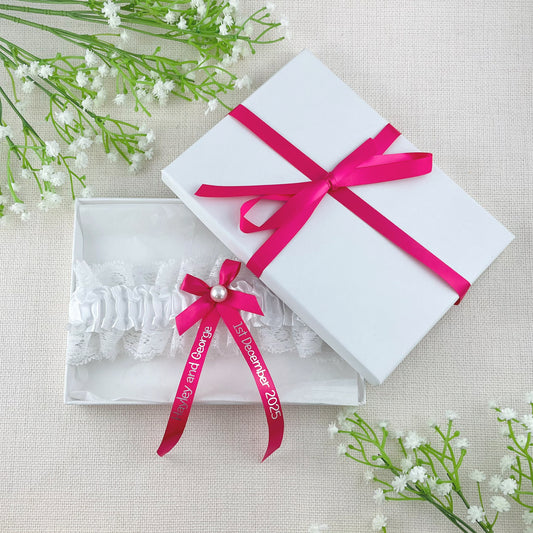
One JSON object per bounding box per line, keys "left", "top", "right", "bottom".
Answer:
{"left": 157, "top": 259, "right": 283, "bottom": 461}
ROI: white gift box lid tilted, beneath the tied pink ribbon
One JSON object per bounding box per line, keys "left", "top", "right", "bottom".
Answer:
{"left": 163, "top": 51, "right": 513, "bottom": 384}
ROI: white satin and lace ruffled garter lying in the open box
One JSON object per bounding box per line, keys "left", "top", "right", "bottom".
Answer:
{"left": 67, "top": 257, "right": 322, "bottom": 365}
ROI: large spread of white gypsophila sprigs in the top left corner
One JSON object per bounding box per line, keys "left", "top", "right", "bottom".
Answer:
{"left": 0, "top": 0, "right": 286, "bottom": 224}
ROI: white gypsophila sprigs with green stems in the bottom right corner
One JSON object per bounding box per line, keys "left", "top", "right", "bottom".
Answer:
{"left": 329, "top": 394, "right": 533, "bottom": 533}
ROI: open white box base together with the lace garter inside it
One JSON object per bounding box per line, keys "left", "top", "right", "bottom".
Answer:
{"left": 65, "top": 199, "right": 365, "bottom": 405}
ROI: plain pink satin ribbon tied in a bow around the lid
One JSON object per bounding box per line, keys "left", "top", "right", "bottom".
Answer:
{"left": 196, "top": 105, "right": 470, "bottom": 304}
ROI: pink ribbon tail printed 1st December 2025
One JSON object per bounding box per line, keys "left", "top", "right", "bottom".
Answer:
{"left": 219, "top": 305, "right": 284, "bottom": 461}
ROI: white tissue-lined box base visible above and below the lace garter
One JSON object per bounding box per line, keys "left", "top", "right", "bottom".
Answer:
{"left": 64, "top": 199, "right": 365, "bottom": 405}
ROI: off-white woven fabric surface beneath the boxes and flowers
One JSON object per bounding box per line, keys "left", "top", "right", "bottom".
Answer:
{"left": 0, "top": 0, "right": 533, "bottom": 533}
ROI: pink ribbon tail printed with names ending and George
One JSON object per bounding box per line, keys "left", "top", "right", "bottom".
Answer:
{"left": 157, "top": 309, "right": 220, "bottom": 457}
